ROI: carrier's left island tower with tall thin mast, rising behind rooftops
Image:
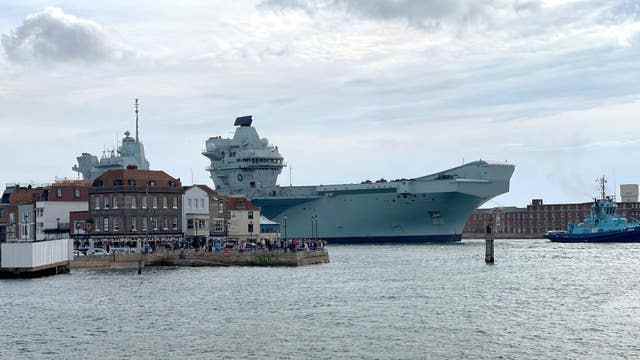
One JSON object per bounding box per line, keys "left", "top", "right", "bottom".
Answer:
{"left": 73, "top": 99, "right": 149, "bottom": 181}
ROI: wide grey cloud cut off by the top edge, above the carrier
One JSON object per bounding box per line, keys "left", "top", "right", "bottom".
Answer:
{"left": 260, "top": 0, "right": 541, "bottom": 28}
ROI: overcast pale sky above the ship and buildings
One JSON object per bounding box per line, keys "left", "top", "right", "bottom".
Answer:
{"left": 0, "top": 0, "right": 640, "bottom": 206}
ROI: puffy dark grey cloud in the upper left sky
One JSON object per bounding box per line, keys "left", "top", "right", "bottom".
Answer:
{"left": 0, "top": 7, "right": 131, "bottom": 63}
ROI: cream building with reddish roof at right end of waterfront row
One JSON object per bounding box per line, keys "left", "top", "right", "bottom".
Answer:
{"left": 224, "top": 196, "right": 260, "bottom": 242}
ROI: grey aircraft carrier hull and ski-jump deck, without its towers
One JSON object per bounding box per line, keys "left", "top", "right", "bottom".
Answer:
{"left": 252, "top": 162, "right": 513, "bottom": 244}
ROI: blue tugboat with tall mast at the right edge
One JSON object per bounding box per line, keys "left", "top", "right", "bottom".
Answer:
{"left": 545, "top": 176, "right": 640, "bottom": 243}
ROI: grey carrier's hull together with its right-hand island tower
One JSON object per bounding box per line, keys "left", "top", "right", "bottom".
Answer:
{"left": 203, "top": 116, "right": 515, "bottom": 243}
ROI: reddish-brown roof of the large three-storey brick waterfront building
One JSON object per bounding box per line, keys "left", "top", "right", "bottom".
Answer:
{"left": 92, "top": 169, "right": 181, "bottom": 188}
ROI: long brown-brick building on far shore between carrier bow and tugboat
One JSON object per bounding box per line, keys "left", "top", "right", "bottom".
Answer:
{"left": 464, "top": 199, "right": 640, "bottom": 239}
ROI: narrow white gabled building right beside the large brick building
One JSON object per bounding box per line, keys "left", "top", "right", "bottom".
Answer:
{"left": 182, "top": 185, "right": 209, "bottom": 239}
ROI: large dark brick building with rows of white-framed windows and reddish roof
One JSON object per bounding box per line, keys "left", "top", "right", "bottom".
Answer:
{"left": 89, "top": 166, "right": 182, "bottom": 245}
